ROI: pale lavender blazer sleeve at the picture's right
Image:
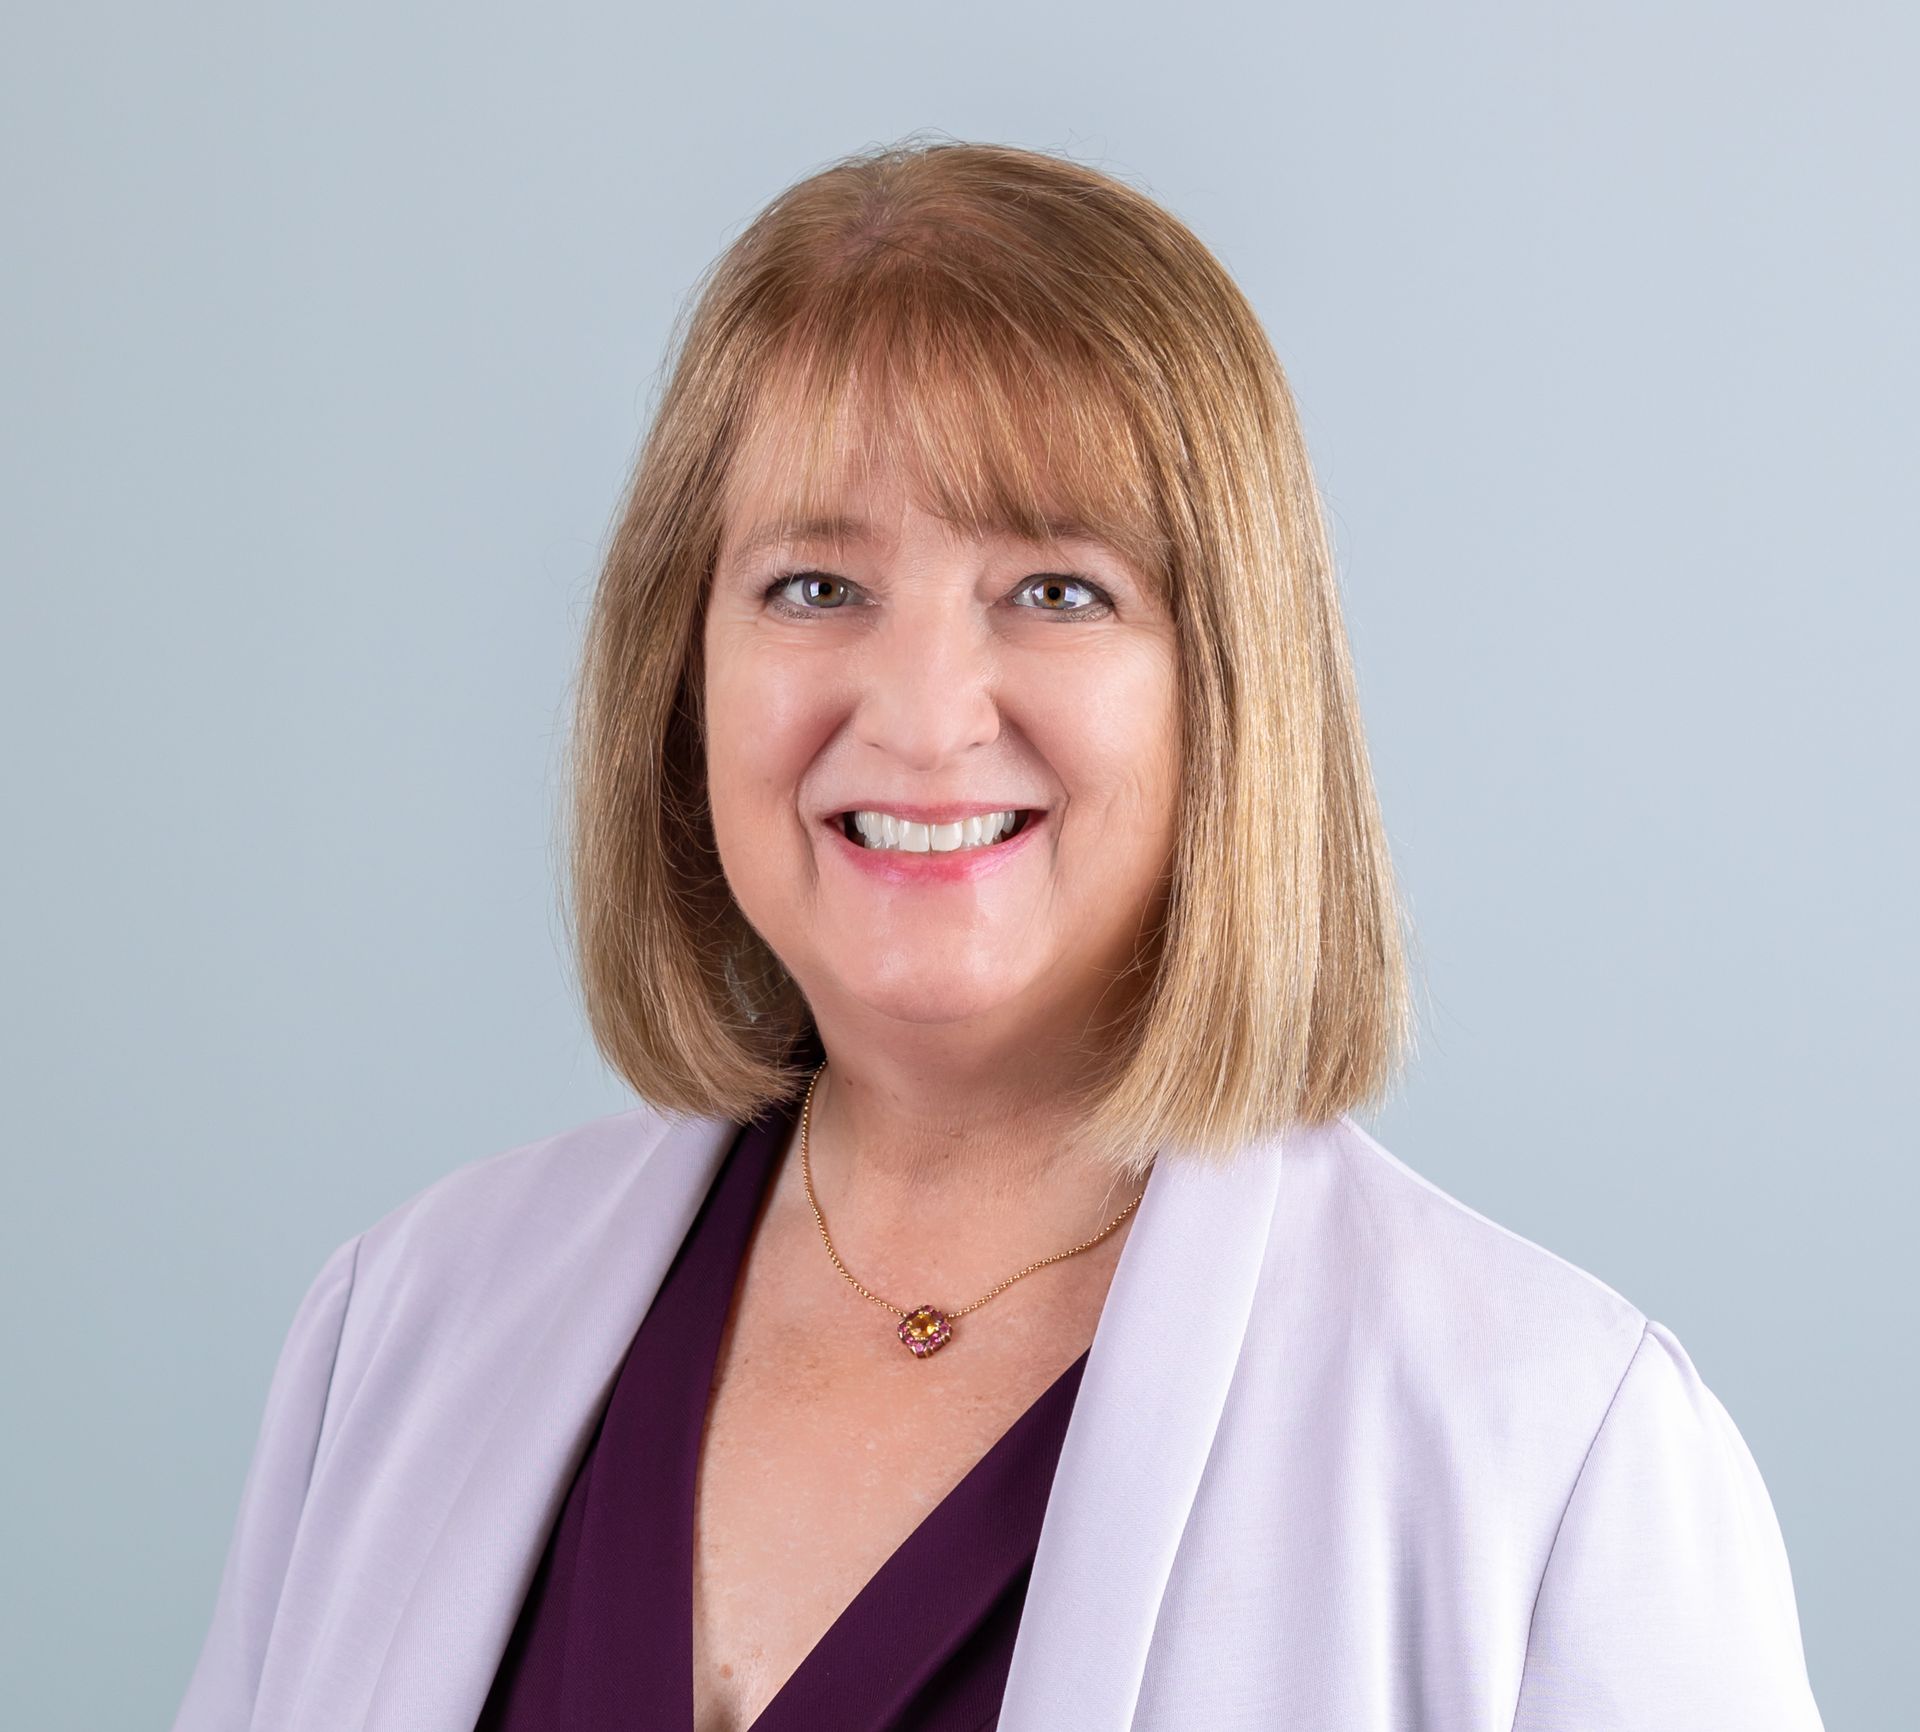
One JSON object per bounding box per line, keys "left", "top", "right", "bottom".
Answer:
{"left": 1513, "top": 1321, "right": 1822, "bottom": 1732}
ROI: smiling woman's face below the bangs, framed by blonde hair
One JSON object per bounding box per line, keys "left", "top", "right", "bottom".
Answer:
{"left": 705, "top": 420, "right": 1181, "bottom": 1043}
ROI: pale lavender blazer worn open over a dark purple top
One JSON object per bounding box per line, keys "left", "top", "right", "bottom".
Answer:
{"left": 175, "top": 1108, "right": 1820, "bottom": 1732}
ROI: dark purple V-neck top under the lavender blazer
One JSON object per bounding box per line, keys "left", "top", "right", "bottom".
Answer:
{"left": 474, "top": 1054, "right": 1087, "bottom": 1732}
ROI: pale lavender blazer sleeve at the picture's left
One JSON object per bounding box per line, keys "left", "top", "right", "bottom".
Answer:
{"left": 173, "top": 1239, "right": 359, "bottom": 1732}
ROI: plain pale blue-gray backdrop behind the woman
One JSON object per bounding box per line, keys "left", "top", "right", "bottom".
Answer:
{"left": 0, "top": 0, "right": 1920, "bottom": 1732}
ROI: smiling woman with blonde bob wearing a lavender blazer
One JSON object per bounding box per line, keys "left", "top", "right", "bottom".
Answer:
{"left": 177, "top": 144, "right": 1820, "bottom": 1732}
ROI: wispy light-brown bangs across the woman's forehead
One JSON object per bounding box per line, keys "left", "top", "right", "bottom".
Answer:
{"left": 726, "top": 261, "right": 1171, "bottom": 597}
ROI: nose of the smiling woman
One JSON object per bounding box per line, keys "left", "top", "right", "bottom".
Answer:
{"left": 851, "top": 582, "right": 1000, "bottom": 770}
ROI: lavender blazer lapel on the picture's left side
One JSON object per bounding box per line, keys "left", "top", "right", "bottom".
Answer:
{"left": 365, "top": 1118, "right": 733, "bottom": 1732}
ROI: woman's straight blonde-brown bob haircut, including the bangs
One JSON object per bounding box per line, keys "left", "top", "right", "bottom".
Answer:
{"left": 568, "top": 138, "right": 1411, "bottom": 1177}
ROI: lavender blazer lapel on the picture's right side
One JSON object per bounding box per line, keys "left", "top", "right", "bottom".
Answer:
{"left": 998, "top": 1139, "right": 1281, "bottom": 1732}
